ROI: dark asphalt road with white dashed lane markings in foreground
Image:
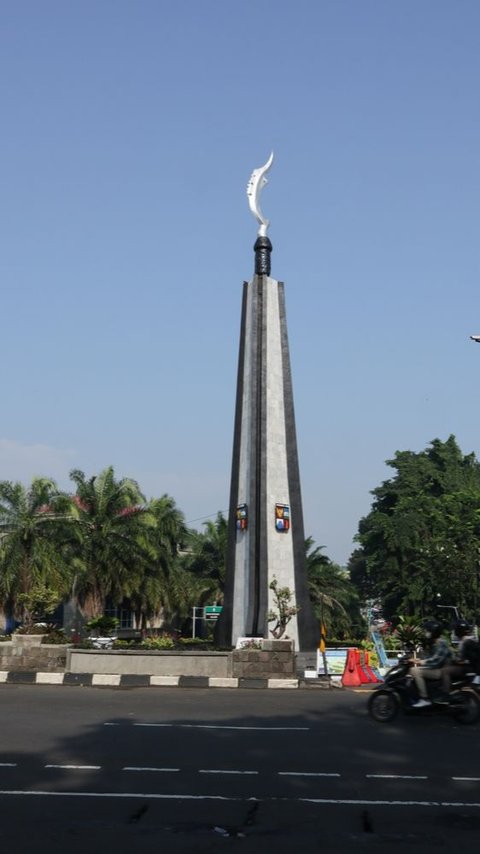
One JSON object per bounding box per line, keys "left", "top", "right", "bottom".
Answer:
{"left": 0, "top": 684, "right": 480, "bottom": 854}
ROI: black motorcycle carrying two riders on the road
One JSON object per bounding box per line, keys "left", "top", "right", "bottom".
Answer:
{"left": 368, "top": 656, "right": 480, "bottom": 724}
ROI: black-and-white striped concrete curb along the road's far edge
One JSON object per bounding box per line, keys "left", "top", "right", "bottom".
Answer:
{"left": 0, "top": 670, "right": 329, "bottom": 690}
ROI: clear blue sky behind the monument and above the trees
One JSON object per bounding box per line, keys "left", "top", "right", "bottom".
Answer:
{"left": 0, "top": 0, "right": 480, "bottom": 563}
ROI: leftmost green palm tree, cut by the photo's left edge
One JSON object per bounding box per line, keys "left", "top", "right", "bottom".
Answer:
{"left": 0, "top": 478, "right": 71, "bottom": 618}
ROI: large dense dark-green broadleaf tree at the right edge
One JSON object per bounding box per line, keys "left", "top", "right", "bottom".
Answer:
{"left": 353, "top": 436, "right": 480, "bottom": 617}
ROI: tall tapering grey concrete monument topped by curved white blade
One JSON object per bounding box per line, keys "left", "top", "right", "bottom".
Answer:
{"left": 216, "top": 154, "right": 319, "bottom": 650}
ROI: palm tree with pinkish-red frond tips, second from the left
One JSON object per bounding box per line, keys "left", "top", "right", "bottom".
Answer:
{"left": 70, "top": 466, "right": 151, "bottom": 616}
